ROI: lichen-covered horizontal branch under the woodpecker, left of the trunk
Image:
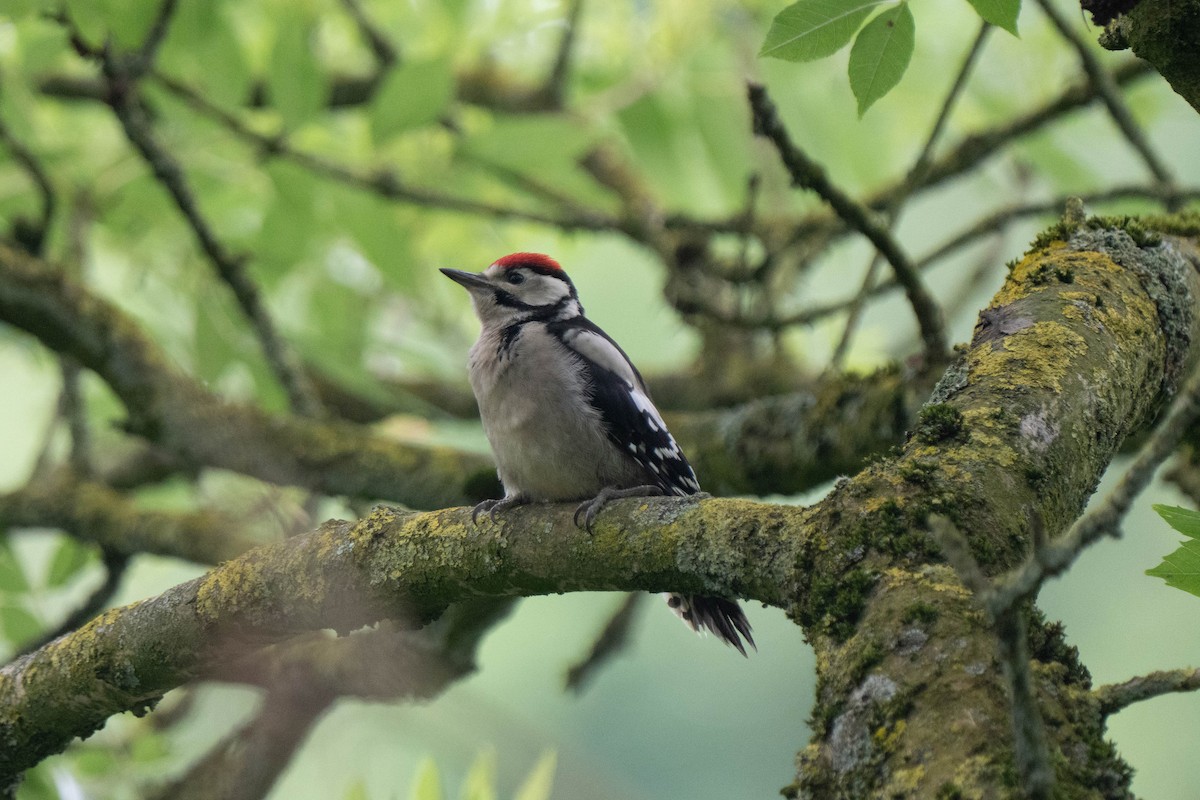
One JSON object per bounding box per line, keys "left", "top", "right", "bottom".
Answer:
{"left": 0, "top": 499, "right": 805, "bottom": 782}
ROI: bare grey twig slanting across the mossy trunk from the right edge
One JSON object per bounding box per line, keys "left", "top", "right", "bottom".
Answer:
{"left": 989, "top": 359, "right": 1200, "bottom": 609}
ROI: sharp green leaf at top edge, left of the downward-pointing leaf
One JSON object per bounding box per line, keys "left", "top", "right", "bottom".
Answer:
{"left": 758, "top": 0, "right": 883, "bottom": 61}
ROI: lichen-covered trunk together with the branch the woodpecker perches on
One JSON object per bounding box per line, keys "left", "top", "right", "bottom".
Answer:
{"left": 0, "top": 214, "right": 1200, "bottom": 796}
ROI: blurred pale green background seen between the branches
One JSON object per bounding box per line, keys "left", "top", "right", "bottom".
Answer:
{"left": 0, "top": 0, "right": 1200, "bottom": 800}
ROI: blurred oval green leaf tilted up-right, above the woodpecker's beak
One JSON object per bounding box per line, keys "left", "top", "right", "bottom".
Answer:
{"left": 371, "top": 60, "right": 455, "bottom": 142}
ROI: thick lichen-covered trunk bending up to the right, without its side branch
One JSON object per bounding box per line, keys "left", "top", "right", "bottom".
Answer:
{"left": 793, "top": 217, "right": 1200, "bottom": 796}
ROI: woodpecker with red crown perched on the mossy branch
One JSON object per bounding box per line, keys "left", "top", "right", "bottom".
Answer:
{"left": 442, "top": 253, "right": 755, "bottom": 655}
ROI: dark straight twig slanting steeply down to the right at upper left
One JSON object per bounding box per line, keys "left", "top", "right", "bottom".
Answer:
{"left": 102, "top": 54, "right": 320, "bottom": 416}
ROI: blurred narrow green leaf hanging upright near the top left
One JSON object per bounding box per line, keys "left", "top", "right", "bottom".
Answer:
{"left": 266, "top": 14, "right": 326, "bottom": 128}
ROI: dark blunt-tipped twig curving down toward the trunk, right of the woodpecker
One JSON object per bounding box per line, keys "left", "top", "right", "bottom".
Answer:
{"left": 748, "top": 84, "right": 946, "bottom": 362}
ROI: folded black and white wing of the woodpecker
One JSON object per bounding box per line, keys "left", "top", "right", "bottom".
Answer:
{"left": 546, "top": 317, "right": 700, "bottom": 494}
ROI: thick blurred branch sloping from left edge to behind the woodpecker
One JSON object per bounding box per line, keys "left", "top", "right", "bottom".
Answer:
{"left": 0, "top": 245, "right": 496, "bottom": 507}
